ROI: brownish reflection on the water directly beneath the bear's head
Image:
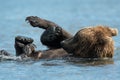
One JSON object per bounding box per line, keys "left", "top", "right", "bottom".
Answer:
{"left": 66, "top": 58, "right": 114, "bottom": 66}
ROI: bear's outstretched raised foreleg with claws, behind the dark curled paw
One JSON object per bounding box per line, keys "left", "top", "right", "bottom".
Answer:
{"left": 26, "top": 16, "right": 72, "bottom": 38}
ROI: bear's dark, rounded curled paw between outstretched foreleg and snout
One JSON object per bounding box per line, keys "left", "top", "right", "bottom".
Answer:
{"left": 40, "top": 27, "right": 67, "bottom": 49}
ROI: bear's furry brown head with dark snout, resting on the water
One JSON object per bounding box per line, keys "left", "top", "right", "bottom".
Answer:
{"left": 61, "top": 26, "right": 118, "bottom": 58}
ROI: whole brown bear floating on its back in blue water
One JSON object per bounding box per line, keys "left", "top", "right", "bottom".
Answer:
{"left": 1, "top": 16, "right": 117, "bottom": 59}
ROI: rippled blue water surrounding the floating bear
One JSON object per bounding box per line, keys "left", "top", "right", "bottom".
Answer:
{"left": 0, "top": 0, "right": 120, "bottom": 80}
